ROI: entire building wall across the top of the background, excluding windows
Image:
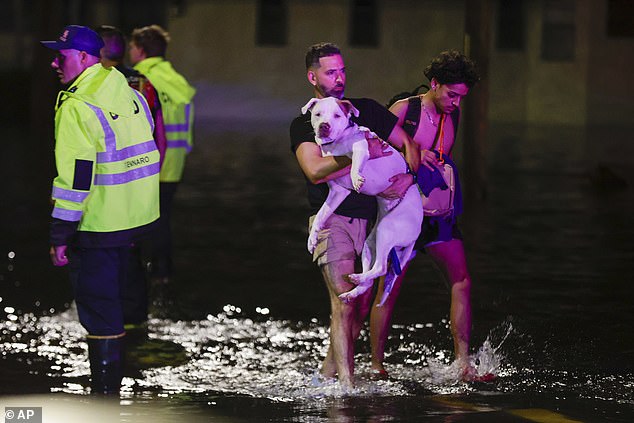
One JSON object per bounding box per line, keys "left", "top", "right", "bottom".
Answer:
{"left": 6, "top": 0, "right": 634, "bottom": 125}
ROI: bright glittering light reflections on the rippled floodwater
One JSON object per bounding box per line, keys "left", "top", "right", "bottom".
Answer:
{"left": 0, "top": 305, "right": 504, "bottom": 401}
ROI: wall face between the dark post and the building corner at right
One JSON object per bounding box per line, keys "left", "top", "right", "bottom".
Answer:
{"left": 489, "top": 0, "right": 593, "bottom": 125}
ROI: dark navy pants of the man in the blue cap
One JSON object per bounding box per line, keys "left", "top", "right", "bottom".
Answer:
{"left": 69, "top": 246, "right": 130, "bottom": 336}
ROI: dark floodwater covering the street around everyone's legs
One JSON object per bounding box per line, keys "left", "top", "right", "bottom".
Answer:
{"left": 0, "top": 124, "right": 634, "bottom": 422}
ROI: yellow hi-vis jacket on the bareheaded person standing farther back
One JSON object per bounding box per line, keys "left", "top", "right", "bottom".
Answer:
{"left": 134, "top": 57, "right": 196, "bottom": 182}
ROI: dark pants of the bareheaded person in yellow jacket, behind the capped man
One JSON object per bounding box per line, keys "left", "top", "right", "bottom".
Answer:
{"left": 151, "top": 182, "right": 178, "bottom": 278}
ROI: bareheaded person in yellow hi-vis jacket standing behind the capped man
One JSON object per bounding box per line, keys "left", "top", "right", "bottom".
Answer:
{"left": 129, "top": 25, "right": 196, "bottom": 284}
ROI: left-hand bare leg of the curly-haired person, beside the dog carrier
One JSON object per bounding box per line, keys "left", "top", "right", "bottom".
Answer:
{"left": 370, "top": 264, "right": 409, "bottom": 371}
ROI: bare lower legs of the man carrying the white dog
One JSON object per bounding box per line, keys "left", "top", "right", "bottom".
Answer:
{"left": 321, "top": 260, "right": 371, "bottom": 387}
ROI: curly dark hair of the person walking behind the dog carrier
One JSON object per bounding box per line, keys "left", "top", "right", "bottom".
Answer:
{"left": 424, "top": 50, "right": 480, "bottom": 88}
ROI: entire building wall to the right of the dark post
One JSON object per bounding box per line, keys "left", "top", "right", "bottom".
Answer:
{"left": 489, "top": 0, "right": 634, "bottom": 125}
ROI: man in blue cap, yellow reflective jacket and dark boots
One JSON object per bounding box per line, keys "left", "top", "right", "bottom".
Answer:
{"left": 41, "top": 25, "right": 160, "bottom": 394}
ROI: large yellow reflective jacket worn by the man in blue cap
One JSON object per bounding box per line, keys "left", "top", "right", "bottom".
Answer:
{"left": 52, "top": 64, "right": 160, "bottom": 232}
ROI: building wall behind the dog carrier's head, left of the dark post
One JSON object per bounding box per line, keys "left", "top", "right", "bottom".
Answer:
{"left": 168, "top": 0, "right": 464, "bottom": 124}
